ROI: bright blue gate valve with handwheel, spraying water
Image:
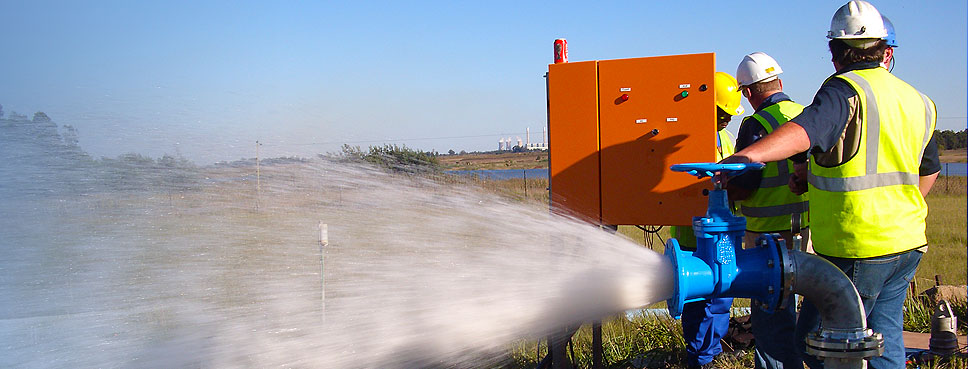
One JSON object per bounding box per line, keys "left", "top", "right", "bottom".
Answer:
{"left": 665, "top": 163, "right": 791, "bottom": 318}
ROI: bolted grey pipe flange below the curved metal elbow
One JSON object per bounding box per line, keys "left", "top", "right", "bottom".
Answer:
{"left": 806, "top": 329, "right": 884, "bottom": 359}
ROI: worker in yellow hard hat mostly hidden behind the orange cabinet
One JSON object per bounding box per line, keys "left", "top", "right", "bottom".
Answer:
{"left": 670, "top": 72, "right": 743, "bottom": 368}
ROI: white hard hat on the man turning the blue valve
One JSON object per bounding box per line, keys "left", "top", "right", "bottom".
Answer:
{"left": 827, "top": 0, "right": 887, "bottom": 48}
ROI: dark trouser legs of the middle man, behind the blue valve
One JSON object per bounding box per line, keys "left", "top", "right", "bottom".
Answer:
{"left": 750, "top": 294, "right": 803, "bottom": 369}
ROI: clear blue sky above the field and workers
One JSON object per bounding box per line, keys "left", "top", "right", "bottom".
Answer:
{"left": 0, "top": 0, "right": 968, "bottom": 164}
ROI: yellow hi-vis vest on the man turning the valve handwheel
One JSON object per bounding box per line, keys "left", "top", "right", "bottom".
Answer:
{"left": 808, "top": 68, "right": 937, "bottom": 258}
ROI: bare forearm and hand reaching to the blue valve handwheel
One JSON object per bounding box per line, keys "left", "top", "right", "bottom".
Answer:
{"left": 720, "top": 121, "right": 810, "bottom": 164}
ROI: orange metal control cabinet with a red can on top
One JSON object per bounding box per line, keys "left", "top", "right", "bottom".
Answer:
{"left": 547, "top": 53, "right": 716, "bottom": 225}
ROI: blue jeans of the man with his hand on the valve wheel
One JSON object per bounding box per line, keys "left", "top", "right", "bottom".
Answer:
{"left": 796, "top": 250, "right": 922, "bottom": 369}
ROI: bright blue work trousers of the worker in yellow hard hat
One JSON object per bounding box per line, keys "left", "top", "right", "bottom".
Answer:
{"left": 682, "top": 297, "right": 733, "bottom": 366}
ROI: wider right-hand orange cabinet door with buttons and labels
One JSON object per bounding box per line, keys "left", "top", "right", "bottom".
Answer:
{"left": 598, "top": 53, "right": 716, "bottom": 225}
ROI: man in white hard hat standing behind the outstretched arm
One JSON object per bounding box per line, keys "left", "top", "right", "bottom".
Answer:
{"left": 728, "top": 52, "right": 809, "bottom": 369}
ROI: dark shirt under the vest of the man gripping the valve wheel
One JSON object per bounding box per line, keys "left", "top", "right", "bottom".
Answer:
{"left": 796, "top": 62, "right": 941, "bottom": 176}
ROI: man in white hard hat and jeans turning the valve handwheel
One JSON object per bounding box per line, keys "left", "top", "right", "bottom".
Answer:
{"left": 723, "top": 1, "right": 941, "bottom": 368}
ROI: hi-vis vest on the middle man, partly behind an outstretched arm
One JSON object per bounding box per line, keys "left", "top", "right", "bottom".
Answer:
{"left": 740, "top": 101, "right": 808, "bottom": 233}
